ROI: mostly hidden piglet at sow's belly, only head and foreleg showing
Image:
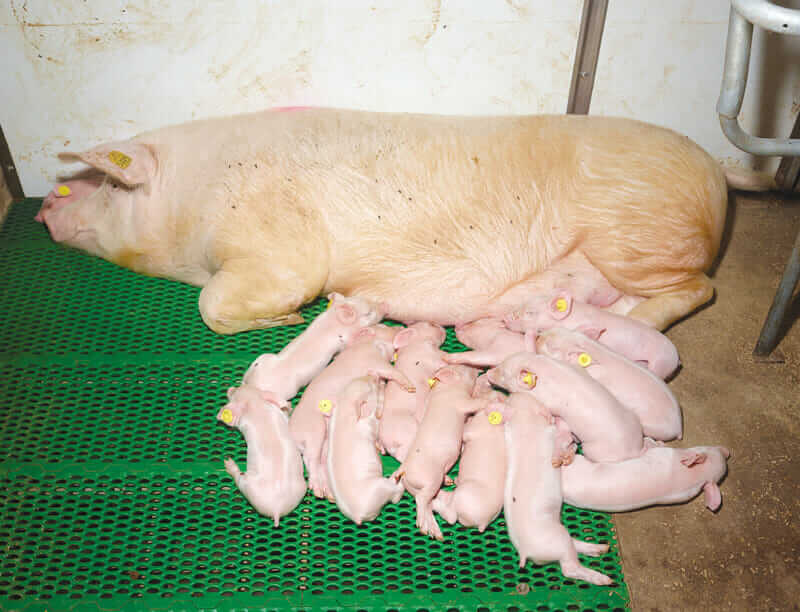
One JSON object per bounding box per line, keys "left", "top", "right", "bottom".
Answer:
{"left": 445, "top": 318, "right": 525, "bottom": 367}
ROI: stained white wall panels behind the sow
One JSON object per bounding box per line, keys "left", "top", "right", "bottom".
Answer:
{"left": 0, "top": 0, "right": 800, "bottom": 196}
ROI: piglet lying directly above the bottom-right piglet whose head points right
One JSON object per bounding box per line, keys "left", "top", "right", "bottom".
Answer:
{"left": 487, "top": 353, "right": 644, "bottom": 461}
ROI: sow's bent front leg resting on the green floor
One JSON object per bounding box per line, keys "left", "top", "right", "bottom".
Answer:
{"left": 199, "top": 259, "right": 324, "bottom": 334}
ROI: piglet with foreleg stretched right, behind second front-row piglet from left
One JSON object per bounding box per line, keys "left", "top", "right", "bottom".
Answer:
{"left": 289, "top": 325, "right": 414, "bottom": 501}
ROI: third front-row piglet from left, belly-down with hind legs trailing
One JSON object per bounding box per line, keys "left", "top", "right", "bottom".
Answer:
{"left": 393, "top": 365, "right": 489, "bottom": 540}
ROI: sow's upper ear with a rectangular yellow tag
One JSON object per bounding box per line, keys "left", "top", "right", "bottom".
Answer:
{"left": 59, "top": 141, "right": 158, "bottom": 187}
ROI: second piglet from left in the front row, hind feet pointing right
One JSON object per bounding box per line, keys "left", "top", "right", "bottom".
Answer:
{"left": 327, "top": 377, "right": 405, "bottom": 525}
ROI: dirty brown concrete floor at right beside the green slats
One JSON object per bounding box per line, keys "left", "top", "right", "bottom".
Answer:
{"left": 614, "top": 193, "right": 800, "bottom": 612}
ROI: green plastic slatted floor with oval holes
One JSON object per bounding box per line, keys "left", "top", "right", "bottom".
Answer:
{"left": 0, "top": 200, "right": 628, "bottom": 611}
